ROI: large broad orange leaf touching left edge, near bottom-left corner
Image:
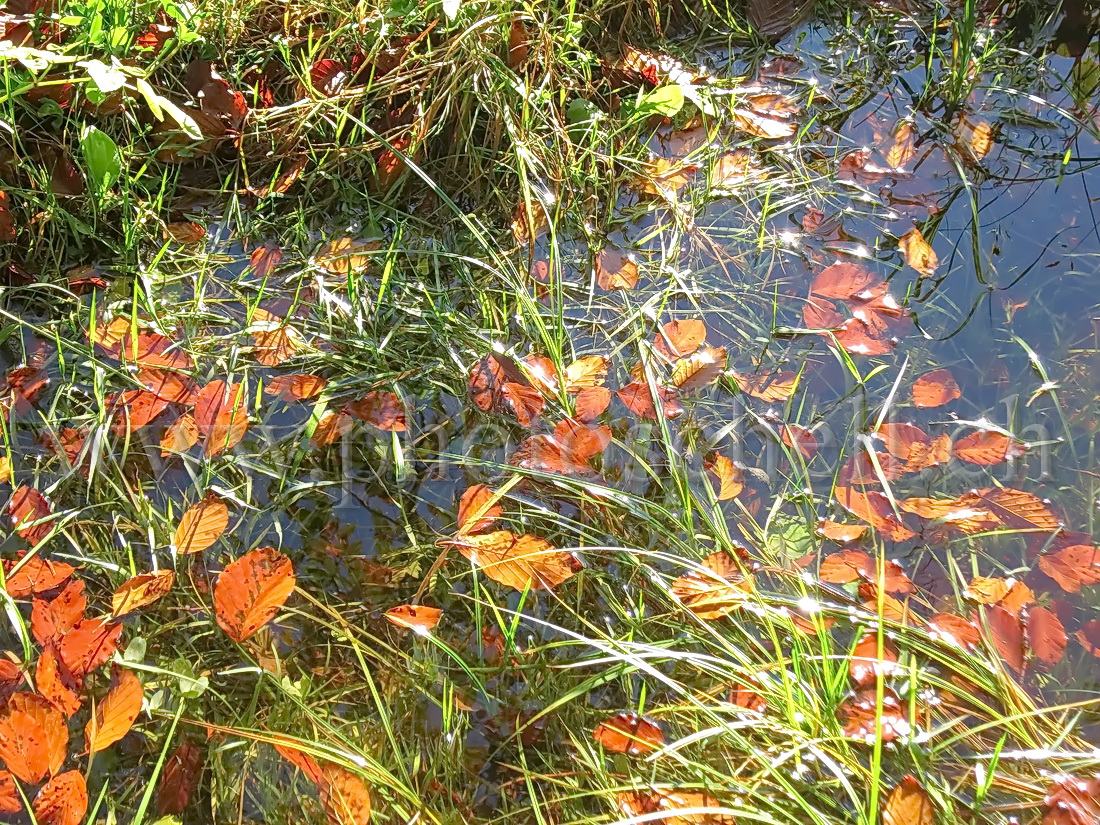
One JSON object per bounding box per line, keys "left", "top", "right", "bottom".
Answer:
{"left": 0, "top": 693, "right": 68, "bottom": 784}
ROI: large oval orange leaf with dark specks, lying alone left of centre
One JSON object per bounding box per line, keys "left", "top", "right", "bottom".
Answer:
{"left": 213, "top": 547, "right": 296, "bottom": 641}
